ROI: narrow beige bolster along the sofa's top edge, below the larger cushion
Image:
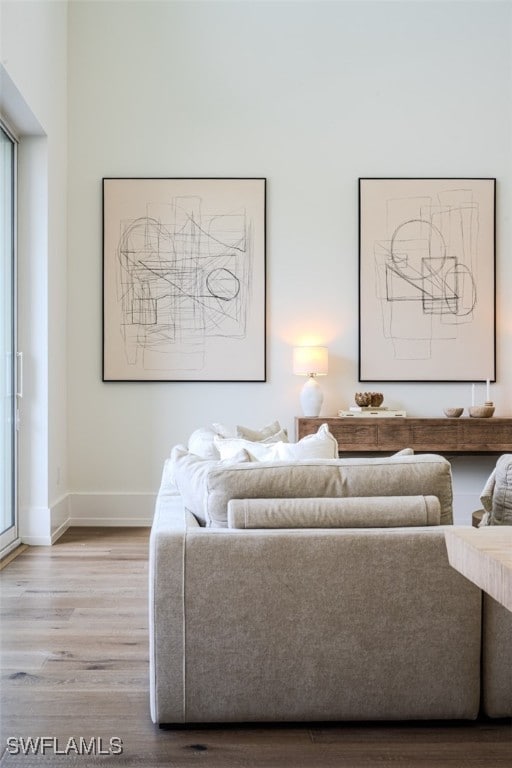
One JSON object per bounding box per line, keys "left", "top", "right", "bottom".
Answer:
{"left": 228, "top": 496, "right": 441, "bottom": 528}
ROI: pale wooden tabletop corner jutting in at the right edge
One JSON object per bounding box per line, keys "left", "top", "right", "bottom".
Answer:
{"left": 445, "top": 525, "right": 512, "bottom": 611}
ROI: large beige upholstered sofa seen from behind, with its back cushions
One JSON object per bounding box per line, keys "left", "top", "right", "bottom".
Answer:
{"left": 149, "top": 451, "right": 512, "bottom": 724}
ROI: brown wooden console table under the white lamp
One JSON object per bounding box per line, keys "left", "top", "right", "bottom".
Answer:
{"left": 296, "top": 416, "right": 512, "bottom": 453}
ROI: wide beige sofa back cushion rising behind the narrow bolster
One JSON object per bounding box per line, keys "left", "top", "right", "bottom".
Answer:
{"left": 204, "top": 454, "right": 453, "bottom": 527}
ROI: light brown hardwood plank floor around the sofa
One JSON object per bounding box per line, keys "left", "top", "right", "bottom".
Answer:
{"left": 0, "top": 528, "right": 512, "bottom": 768}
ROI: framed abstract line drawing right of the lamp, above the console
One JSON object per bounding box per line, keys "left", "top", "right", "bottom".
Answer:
{"left": 359, "top": 178, "right": 496, "bottom": 381}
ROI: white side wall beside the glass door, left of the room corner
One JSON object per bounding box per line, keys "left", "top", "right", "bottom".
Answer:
{"left": 0, "top": 0, "right": 68, "bottom": 543}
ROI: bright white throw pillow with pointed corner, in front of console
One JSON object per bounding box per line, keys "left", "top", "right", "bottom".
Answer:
{"left": 215, "top": 424, "right": 338, "bottom": 461}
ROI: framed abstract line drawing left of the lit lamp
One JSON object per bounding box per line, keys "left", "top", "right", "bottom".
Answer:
{"left": 103, "top": 178, "right": 266, "bottom": 381}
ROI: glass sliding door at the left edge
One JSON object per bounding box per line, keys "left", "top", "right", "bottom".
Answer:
{"left": 0, "top": 123, "right": 21, "bottom": 554}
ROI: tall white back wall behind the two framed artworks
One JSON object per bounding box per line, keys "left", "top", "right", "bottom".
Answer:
{"left": 69, "top": 1, "right": 512, "bottom": 514}
